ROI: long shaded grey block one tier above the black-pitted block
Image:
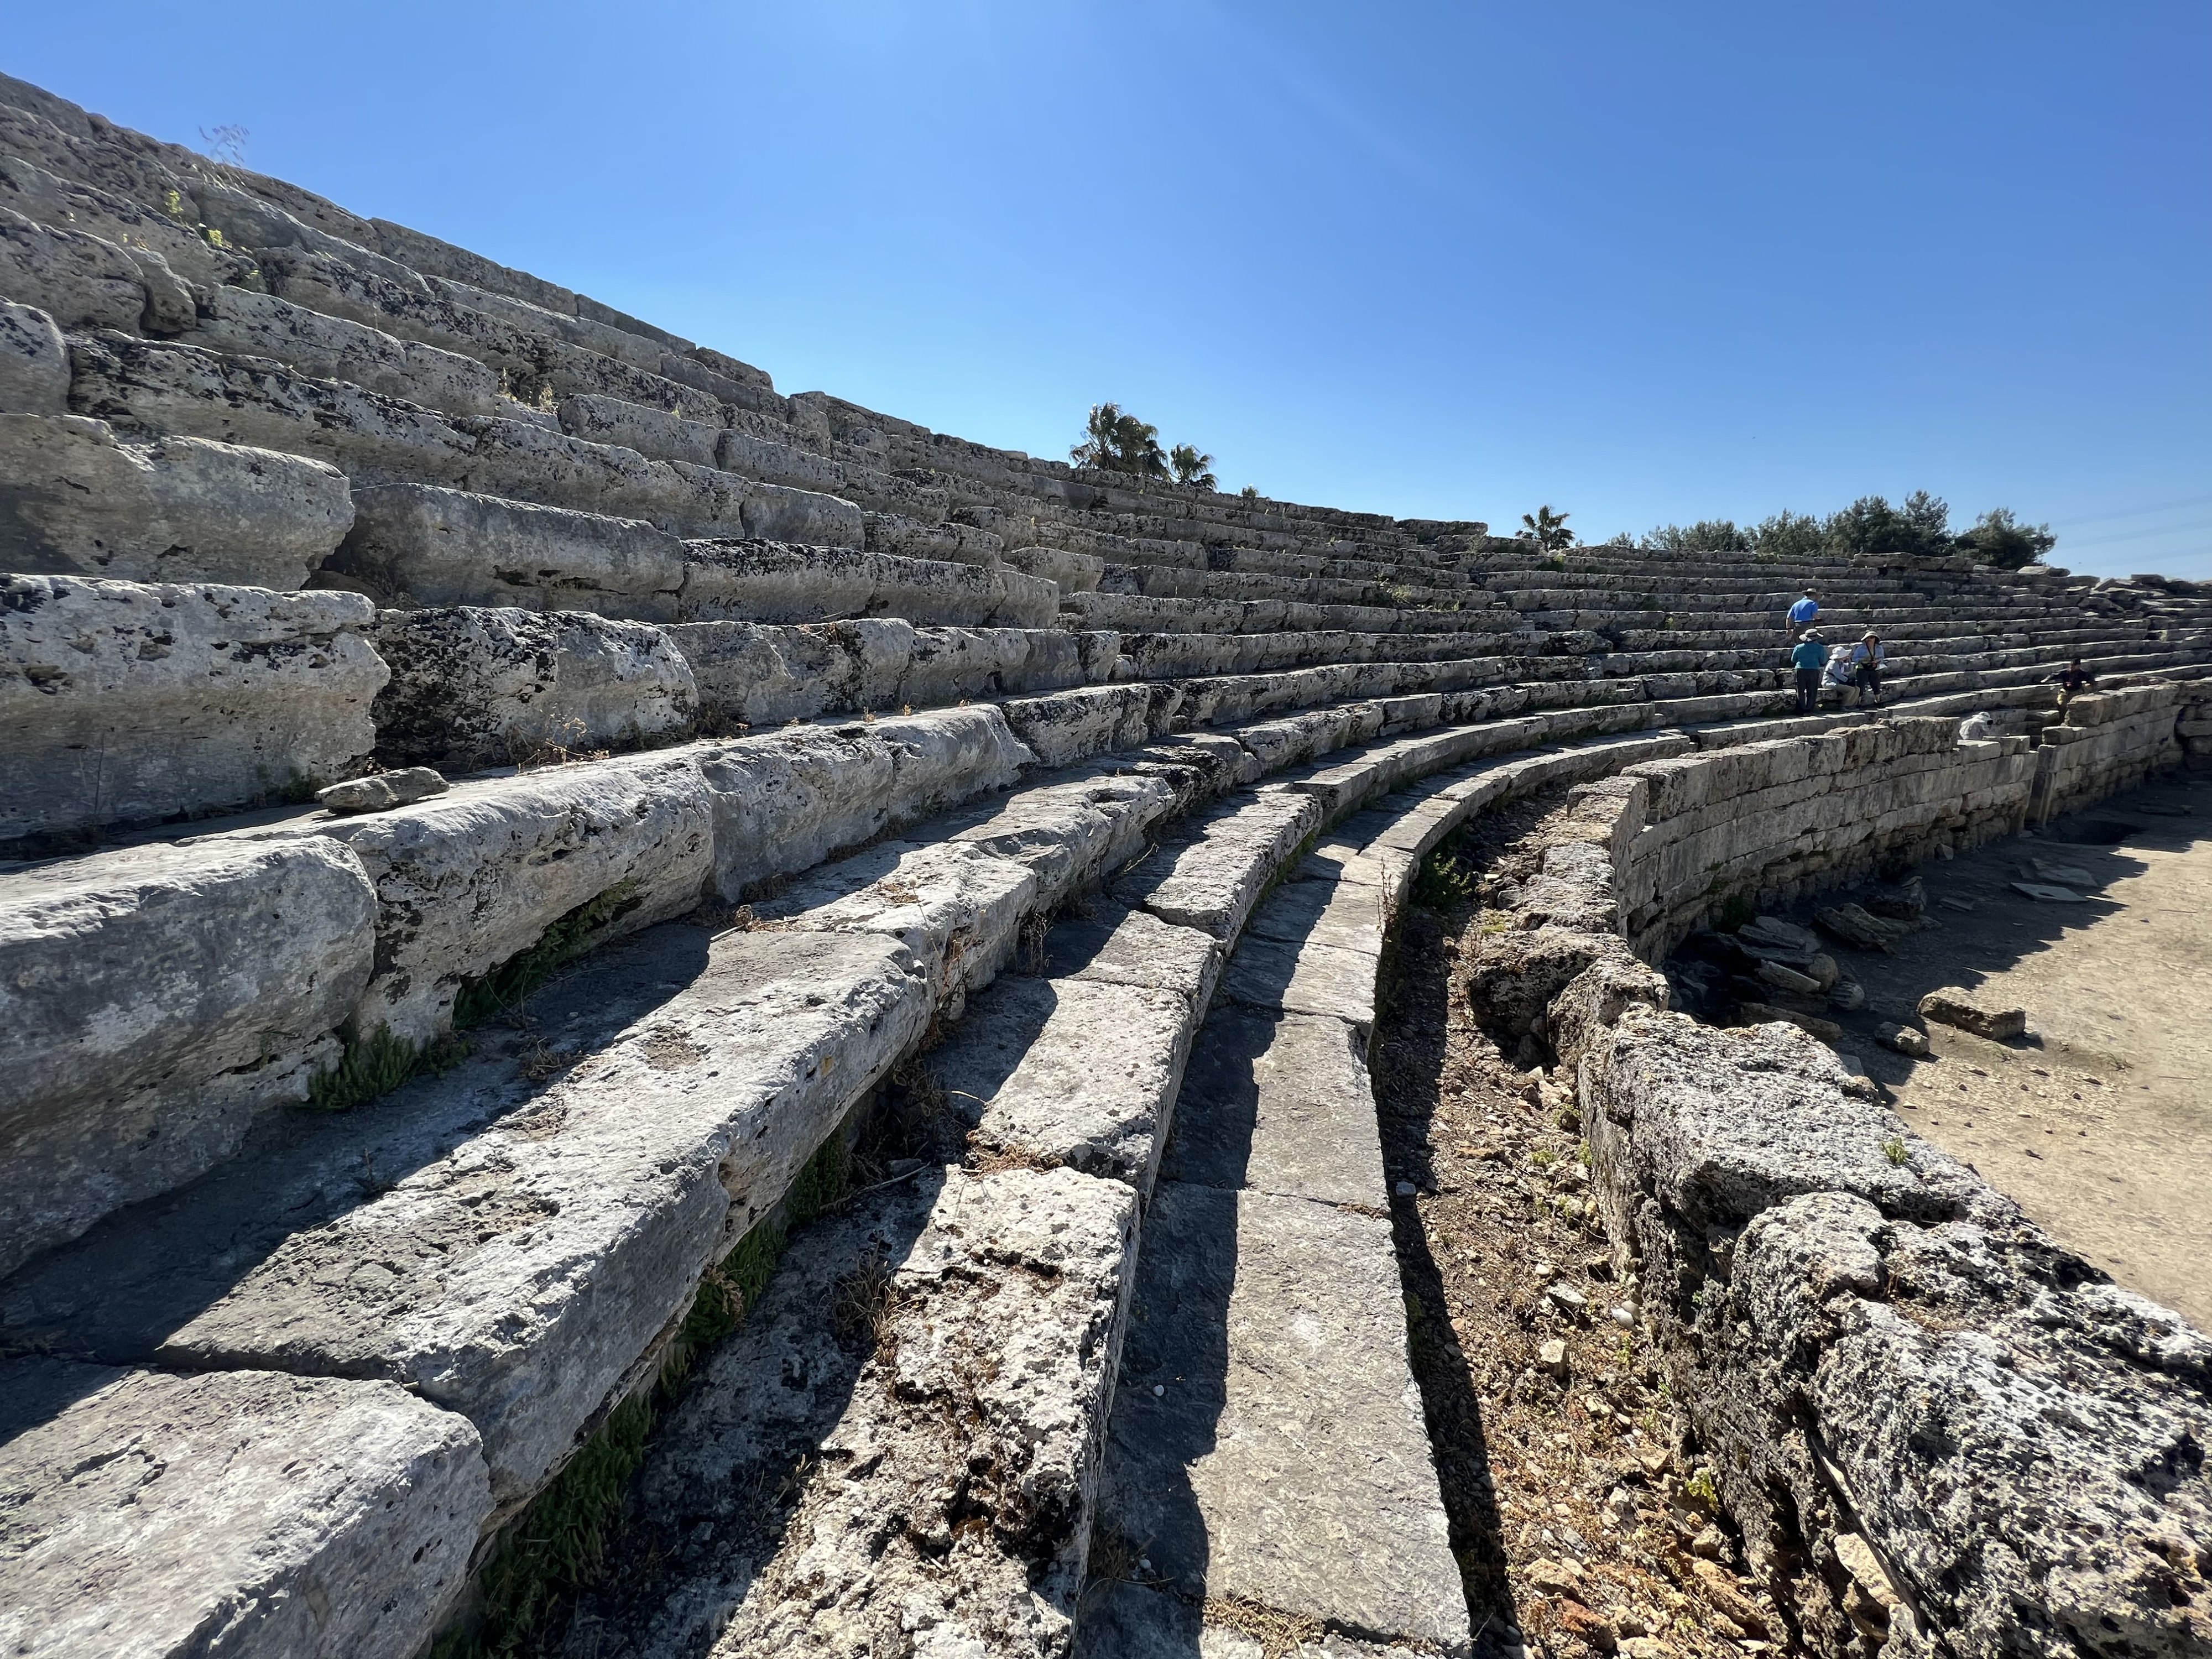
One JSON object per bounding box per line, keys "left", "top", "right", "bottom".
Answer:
{"left": 321, "top": 484, "right": 684, "bottom": 622}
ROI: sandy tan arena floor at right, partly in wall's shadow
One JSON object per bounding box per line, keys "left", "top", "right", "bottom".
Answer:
{"left": 1790, "top": 774, "right": 2212, "bottom": 1329}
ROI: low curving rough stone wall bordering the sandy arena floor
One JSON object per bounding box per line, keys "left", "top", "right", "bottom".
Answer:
{"left": 1469, "top": 708, "right": 2212, "bottom": 1659}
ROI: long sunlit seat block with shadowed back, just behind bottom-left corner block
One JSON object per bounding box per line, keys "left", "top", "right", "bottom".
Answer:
{"left": 0, "top": 927, "right": 929, "bottom": 1506}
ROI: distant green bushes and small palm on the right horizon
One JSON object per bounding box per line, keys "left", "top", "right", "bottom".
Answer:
{"left": 1517, "top": 489, "right": 2059, "bottom": 571}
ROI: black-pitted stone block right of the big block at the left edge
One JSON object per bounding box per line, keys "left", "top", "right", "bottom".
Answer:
{"left": 372, "top": 606, "right": 699, "bottom": 772}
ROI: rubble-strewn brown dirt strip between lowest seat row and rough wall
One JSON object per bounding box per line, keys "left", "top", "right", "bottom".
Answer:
{"left": 1374, "top": 799, "right": 1785, "bottom": 1659}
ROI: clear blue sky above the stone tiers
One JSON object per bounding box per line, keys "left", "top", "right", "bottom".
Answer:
{"left": 0, "top": 0, "right": 2212, "bottom": 577}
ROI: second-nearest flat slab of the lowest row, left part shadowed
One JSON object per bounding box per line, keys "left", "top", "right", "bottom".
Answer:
{"left": 1161, "top": 1006, "right": 1389, "bottom": 1210}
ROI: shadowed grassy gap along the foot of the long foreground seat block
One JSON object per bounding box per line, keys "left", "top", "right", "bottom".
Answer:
{"left": 431, "top": 1130, "right": 852, "bottom": 1659}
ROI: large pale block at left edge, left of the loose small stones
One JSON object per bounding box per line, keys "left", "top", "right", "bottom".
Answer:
{"left": 0, "top": 575, "right": 387, "bottom": 845}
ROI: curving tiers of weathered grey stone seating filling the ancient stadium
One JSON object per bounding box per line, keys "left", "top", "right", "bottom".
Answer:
{"left": 0, "top": 77, "right": 2212, "bottom": 1659}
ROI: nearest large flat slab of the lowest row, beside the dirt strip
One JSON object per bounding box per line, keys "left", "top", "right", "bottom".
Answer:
{"left": 1099, "top": 1181, "right": 1469, "bottom": 1652}
